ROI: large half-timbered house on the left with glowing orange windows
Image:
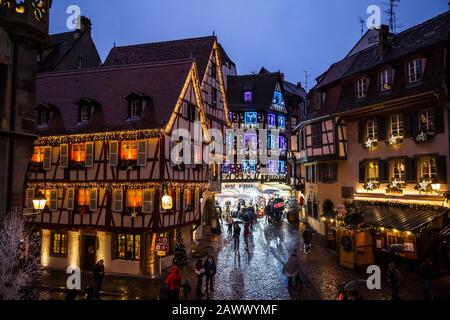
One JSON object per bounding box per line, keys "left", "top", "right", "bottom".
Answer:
{"left": 24, "top": 34, "right": 234, "bottom": 274}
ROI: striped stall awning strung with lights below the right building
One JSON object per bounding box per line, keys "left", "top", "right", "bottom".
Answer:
{"left": 360, "top": 206, "right": 447, "bottom": 231}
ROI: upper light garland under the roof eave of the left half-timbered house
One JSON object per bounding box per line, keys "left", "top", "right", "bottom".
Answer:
{"left": 34, "top": 129, "right": 164, "bottom": 146}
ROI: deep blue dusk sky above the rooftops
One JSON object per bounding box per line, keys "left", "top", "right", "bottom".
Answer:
{"left": 50, "top": 0, "right": 448, "bottom": 88}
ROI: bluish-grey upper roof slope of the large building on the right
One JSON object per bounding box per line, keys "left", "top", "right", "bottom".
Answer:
{"left": 312, "top": 11, "right": 450, "bottom": 90}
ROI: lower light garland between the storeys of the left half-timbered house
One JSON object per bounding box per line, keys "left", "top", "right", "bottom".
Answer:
{"left": 27, "top": 182, "right": 208, "bottom": 190}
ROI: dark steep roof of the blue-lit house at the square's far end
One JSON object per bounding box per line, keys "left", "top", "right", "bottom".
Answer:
{"left": 227, "top": 72, "right": 283, "bottom": 111}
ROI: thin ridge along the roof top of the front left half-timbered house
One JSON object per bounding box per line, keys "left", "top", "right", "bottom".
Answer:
{"left": 38, "top": 59, "right": 194, "bottom": 78}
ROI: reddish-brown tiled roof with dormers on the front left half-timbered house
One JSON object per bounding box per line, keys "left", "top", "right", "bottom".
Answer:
{"left": 37, "top": 59, "right": 192, "bottom": 135}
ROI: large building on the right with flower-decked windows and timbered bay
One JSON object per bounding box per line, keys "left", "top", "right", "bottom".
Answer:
{"left": 298, "top": 11, "right": 450, "bottom": 259}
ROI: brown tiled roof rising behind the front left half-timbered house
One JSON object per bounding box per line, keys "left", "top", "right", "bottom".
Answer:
{"left": 104, "top": 36, "right": 234, "bottom": 79}
